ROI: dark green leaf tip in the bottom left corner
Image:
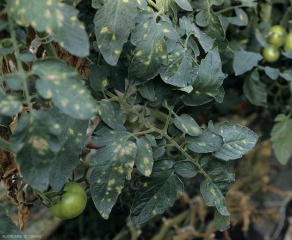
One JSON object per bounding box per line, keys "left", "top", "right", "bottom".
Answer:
{"left": 0, "top": 205, "right": 24, "bottom": 235}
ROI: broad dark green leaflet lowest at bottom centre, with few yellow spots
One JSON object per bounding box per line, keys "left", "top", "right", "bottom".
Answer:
{"left": 131, "top": 160, "right": 183, "bottom": 224}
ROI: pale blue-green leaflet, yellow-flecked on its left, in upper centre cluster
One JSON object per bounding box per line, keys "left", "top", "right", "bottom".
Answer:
{"left": 160, "top": 44, "right": 194, "bottom": 87}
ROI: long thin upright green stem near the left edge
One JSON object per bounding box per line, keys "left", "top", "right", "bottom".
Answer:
{"left": 8, "top": 16, "right": 32, "bottom": 109}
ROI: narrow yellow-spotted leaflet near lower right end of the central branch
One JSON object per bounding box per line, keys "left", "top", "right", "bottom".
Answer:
{"left": 200, "top": 180, "right": 230, "bottom": 216}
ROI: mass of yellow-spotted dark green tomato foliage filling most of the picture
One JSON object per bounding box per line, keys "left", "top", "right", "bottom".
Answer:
{"left": 0, "top": 0, "right": 274, "bottom": 234}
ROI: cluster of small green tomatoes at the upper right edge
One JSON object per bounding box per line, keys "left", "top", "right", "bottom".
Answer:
{"left": 263, "top": 25, "right": 292, "bottom": 63}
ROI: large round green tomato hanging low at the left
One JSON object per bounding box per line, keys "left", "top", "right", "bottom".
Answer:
{"left": 49, "top": 182, "right": 87, "bottom": 219}
